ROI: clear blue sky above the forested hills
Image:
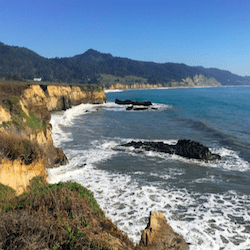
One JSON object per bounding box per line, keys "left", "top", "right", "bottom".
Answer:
{"left": 0, "top": 0, "right": 250, "bottom": 76}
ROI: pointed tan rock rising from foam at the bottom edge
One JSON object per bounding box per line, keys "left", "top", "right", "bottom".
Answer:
{"left": 140, "top": 212, "right": 189, "bottom": 250}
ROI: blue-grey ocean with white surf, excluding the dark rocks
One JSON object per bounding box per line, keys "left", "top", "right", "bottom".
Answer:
{"left": 48, "top": 87, "right": 250, "bottom": 250}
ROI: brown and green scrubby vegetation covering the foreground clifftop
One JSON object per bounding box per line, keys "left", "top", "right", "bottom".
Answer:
{"left": 0, "top": 177, "right": 135, "bottom": 250}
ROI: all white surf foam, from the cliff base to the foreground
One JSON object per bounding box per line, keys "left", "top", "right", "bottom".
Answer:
{"left": 48, "top": 104, "right": 250, "bottom": 250}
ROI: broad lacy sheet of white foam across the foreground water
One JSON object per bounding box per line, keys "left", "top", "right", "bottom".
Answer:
{"left": 49, "top": 159, "right": 250, "bottom": 249}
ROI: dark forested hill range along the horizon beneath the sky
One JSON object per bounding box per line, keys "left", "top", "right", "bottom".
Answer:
{"left": 0, "top": 43, "right": 250, "bottom": 86}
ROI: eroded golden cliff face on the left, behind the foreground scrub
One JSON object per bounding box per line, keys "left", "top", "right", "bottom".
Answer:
{"left": 0, "top": 83, "right": 106, "bottom": 194}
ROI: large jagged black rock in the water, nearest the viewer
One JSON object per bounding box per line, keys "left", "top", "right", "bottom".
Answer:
{"left": 121, "top": 140, "right": 221, "bottom": 160}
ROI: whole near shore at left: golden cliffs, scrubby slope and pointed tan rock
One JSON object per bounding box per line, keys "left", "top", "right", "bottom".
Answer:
{"left": 0, "top": 82, "right": 189, "bottom": 250}
